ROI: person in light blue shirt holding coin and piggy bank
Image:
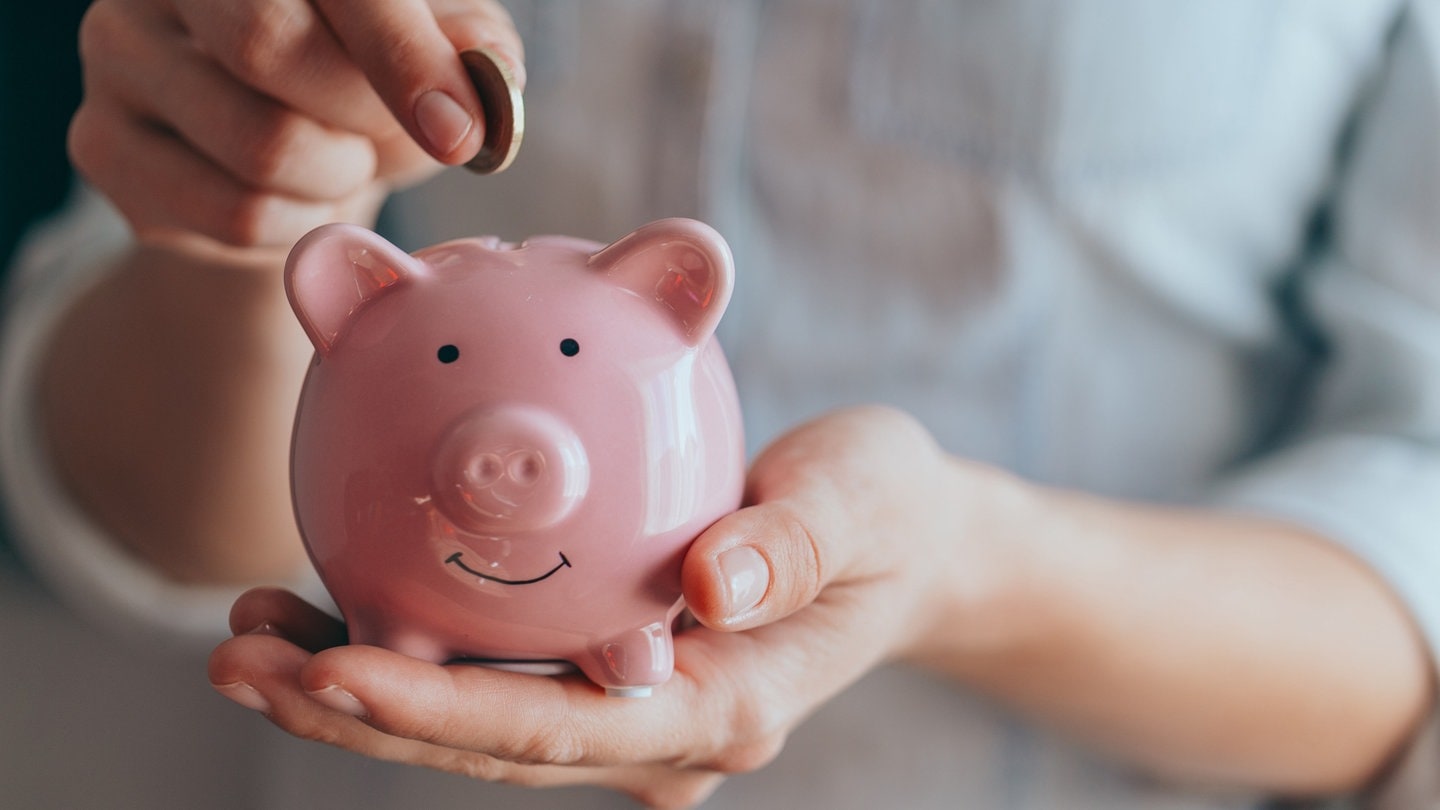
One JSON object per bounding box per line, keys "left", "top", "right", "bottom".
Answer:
{"left": 0, "top": 0, "right": 1440, "bottom": 809}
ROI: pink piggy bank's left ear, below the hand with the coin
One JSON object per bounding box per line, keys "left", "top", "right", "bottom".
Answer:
{"left": 285, "top": 225, "right": 423, "bottom": 357}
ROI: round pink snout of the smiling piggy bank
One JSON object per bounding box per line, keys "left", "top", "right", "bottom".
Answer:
{"left": 433, "top": 408, "right": 590, "bottom": 535}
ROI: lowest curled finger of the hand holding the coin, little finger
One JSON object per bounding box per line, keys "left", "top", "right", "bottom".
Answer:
{"left": 69, "top": 101, "right": 337, "bottom": 246}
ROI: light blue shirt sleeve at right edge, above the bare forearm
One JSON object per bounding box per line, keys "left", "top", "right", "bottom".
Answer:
{"left": 1218, "top": 0, "right": 1440, "bottom": 806}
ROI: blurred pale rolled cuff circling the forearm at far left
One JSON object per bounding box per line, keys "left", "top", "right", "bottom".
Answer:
{"left": 0, "top": 186, "right": 328, "bottom": 647}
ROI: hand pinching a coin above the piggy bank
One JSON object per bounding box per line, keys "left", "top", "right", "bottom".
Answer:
{"left": 69, "top": 0, "right": 524, "bottom": 248}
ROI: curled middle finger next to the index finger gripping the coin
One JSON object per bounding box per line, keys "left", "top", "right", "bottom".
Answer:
{"left": 177, "top": 0, "right": 402, "bottom": 140}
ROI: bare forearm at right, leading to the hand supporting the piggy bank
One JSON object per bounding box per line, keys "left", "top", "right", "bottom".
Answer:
{"left": 920, "top": 464, "right": 1431, "bottom": 794}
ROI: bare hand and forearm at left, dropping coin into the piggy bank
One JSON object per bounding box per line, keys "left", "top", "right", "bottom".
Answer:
{"left": 54, "top": 0, "right": 524, "bottom": 584}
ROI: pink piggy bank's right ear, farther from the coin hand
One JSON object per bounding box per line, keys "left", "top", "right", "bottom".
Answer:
{"left": 590, "top": 219, "right": 734, "bottom": 346}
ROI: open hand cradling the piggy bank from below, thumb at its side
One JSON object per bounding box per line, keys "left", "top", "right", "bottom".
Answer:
{"left": 210, "top": 409, "right": 1002, "bottom": 807}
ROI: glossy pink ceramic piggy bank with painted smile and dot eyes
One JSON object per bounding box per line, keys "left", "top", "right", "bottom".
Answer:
{"left": 285, "top": 219, "right": 744, "bottom": 696}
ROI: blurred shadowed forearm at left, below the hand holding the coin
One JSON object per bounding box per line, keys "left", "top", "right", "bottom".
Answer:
{"left": 40, "top": 239, "right": 310, "bottom": 584}
